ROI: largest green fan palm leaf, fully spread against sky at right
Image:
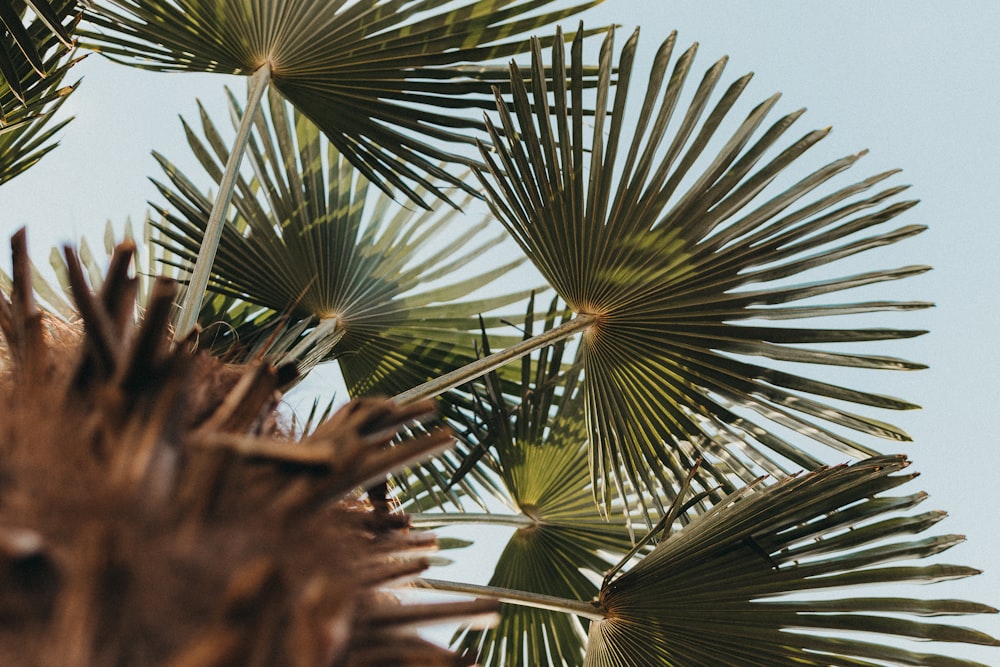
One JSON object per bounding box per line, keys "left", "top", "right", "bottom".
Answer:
{"left": 481, "top": 24, "right": 929, "bottom": 502}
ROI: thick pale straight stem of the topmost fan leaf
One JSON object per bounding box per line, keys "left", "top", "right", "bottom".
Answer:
{"left": 175, "top": 62, "right": 271, "bottom": 340}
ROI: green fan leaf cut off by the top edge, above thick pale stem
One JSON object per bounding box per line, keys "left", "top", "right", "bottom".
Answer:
{"left": 80, "top": 0, "right": 601, "bottom": 207}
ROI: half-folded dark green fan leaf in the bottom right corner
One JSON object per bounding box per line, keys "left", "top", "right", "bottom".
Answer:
{"left": 586, "top": 456, "right": 1000, "bottom": 667}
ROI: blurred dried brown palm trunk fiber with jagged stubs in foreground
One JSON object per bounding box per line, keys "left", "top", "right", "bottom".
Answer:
{"left": 0, "top": 231, "right": 494, "bottom": 667}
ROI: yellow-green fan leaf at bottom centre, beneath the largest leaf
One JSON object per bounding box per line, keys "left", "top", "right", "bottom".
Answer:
{"left": 412, "top": 302, "right": 632, "bottom": 666}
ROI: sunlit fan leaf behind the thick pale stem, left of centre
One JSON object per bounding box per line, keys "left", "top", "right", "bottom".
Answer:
{"left": 154, "top": 87, "right": 528, "bottom": 396}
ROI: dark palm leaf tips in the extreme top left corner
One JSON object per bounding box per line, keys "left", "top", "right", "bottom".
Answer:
{"left": 0, "top": 0, "right": 78, "bottom": 104}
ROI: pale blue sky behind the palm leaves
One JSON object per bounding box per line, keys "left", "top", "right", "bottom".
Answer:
{"left": 0, "top": 0, "right": 1000, "bottom": 664}
